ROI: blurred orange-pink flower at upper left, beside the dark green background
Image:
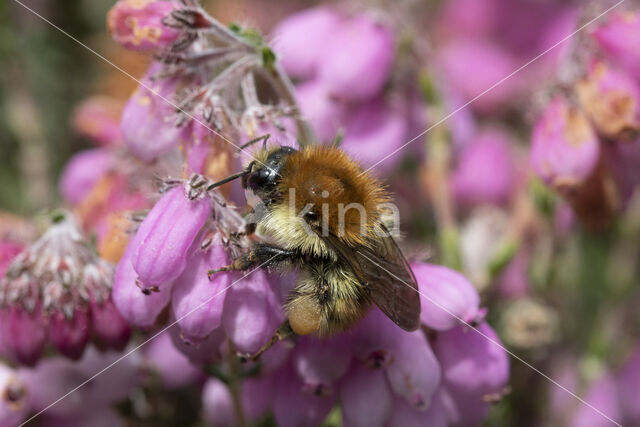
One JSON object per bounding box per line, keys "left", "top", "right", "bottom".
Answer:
{"left": 71, "top": 96, "right": 123, "bottom": 146}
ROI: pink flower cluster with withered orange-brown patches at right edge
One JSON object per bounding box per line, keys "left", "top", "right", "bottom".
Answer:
{"left": 531, "top": 13, "right": 640, "bottom": 228}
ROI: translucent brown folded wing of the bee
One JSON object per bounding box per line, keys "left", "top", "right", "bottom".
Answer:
{"left": 328, "top": 229, "right": 420, "bottom": 331}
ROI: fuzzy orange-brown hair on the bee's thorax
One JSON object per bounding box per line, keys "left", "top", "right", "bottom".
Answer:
{"left": 279, "top": 146, "right": 389, "bottom": 246}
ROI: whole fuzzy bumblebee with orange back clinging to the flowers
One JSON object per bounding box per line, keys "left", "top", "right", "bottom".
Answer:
{"left": 210, "top": 146, "right": 420, "bottom": 353}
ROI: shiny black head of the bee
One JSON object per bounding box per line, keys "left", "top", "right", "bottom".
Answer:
{"left": 242, "top": 147, "right": 296, "bottom": 201}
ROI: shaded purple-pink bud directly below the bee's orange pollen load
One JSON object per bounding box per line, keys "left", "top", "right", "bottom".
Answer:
{"left": 293, "top": 334, "right": 352, "bottom": 393}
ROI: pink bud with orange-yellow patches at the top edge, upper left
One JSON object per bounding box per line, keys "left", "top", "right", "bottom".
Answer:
{"left": 107, "top": 0, "right": 178, "bottom": 50}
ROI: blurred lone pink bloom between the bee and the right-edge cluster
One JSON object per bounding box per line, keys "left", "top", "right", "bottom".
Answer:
{"left": 452, "top": 129, "right": 515, "bottom": 204}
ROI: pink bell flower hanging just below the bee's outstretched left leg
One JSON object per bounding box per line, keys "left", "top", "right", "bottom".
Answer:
{"left": 171, "top": 235, "right": 231, "bottom": 339}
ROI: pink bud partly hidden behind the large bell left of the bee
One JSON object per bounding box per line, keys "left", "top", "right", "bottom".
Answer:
{"left": 112, "top": 238, "right": 171, "bottom": 328}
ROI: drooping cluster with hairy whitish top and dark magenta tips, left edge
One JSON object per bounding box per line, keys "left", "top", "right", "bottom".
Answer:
{"left": 0, "top": 212, "right": 128, "bottom": 365}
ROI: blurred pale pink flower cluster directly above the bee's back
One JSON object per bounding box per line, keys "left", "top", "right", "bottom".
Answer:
{"left": 273, "top": 6, "right": 424, "bottom": 170}
